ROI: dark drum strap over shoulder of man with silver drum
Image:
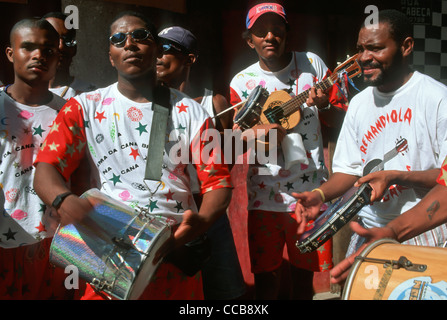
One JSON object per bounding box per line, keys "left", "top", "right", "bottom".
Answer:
{"left": 144, "top": 86, "right": 171, "bottom": 181}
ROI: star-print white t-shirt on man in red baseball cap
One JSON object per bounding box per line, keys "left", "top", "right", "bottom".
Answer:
{"left": 230, "top": 52, "right": 328, "bottom": 212}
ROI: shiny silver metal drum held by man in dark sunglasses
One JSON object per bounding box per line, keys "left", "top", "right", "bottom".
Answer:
{"left": 50, "top": 189, "right": 171, "bottom": 300}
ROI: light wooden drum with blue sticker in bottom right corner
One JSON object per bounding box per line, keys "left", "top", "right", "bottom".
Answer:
{"left": 342, "top": 239, "right": 447, "bottom": 300}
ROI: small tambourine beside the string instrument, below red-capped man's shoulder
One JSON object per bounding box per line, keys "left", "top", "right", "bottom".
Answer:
{"left": 233, "top": 86, "right": 269, "bottom": 130}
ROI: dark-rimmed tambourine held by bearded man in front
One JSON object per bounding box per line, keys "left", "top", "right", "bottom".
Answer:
{"left": 296, "top": 183, "right": 372, "bottom": 253}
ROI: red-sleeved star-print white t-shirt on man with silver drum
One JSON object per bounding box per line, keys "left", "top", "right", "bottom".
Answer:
{"left": 36, "top": 83, "right": 231, "bottom": 223}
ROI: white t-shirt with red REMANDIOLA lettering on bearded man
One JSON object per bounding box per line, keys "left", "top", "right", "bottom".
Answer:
{"left": 333, "top": 72, "right": 447, "bottom": 228}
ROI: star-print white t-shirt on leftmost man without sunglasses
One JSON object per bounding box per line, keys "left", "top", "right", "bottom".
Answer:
{"left": 0, "top": 91, "right": 66, "bottom": 248}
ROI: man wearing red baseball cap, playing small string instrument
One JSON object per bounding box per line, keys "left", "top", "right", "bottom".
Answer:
{"left": 230, "top": 2, "right": 347, "bottom": 299}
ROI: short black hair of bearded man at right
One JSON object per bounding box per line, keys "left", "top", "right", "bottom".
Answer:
{"left": 362, "top": 9, "right": 413, "bottom": 43}
